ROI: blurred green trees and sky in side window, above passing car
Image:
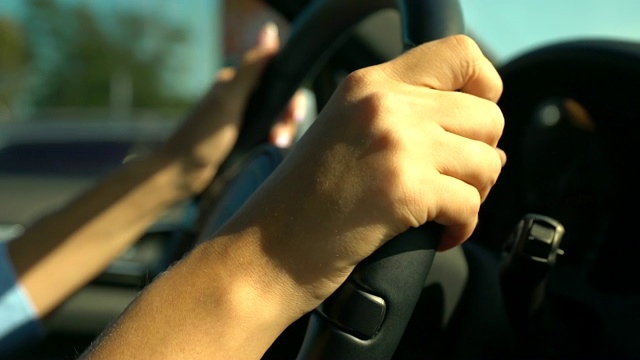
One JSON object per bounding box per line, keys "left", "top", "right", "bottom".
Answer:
{"left": 0, "top": 0, "right": 221, "bottom": 122}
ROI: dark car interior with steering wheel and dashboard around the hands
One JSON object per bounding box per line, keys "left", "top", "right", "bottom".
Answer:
{"left": 5, "top": 0, "right": 640, "bottom": 359}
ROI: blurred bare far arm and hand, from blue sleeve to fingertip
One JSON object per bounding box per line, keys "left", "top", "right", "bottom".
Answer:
{"left": 4, "top": 22, "right": 278, "bottom": 316}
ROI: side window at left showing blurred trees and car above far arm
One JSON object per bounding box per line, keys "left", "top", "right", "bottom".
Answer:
{"left": 0, "top": 0, "right": 209, "bottom": 245}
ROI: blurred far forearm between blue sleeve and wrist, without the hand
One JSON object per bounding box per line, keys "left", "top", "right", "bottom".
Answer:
{"left": 9, "top": 153, "right": 198, "bottom": 316}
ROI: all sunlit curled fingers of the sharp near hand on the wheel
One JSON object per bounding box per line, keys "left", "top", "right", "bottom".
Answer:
{"left": 372, "top": 36, "right": 506, "bottom": 251}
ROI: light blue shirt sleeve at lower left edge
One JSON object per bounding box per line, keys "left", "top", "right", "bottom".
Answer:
{"left": 0, "top": 242, "right": 44, "bottom": 358}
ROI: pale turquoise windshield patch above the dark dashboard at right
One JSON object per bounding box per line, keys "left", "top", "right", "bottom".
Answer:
{"left": 460, "top": 0, "right": 640, "bottom": 64}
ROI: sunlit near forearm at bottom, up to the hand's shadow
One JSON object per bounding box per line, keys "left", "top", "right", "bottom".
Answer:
{"left": 85, "top": 231, "right": 302, "bottom": 359}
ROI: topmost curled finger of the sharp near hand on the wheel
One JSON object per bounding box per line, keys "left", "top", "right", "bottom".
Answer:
{"left": 382, "top": 35, "right": 502, "bottom": 102}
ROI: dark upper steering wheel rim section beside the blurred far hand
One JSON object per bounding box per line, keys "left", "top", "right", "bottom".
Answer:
{"left": 222, "top": 0, "right": 395, "bottom": 170}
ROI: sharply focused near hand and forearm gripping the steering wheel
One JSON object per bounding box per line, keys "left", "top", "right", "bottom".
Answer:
{"left": 84, "top": 36, "right": 506, "bottom": 359}
